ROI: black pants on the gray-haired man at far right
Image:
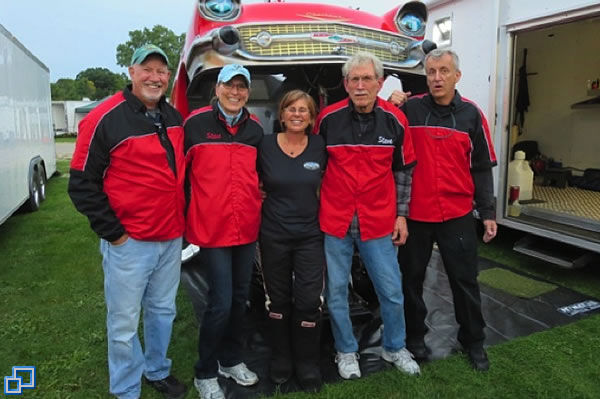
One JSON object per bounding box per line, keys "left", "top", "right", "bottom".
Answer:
{"left": 398, "top": 213, "right": 485, "bottom": 348}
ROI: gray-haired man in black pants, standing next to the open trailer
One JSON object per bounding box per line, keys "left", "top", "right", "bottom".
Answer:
{"left": 390, "top": 50, "right": 497, "bottom": 371}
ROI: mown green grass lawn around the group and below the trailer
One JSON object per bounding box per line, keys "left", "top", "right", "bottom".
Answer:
{"left": 0, "top": 161, "right": 600, "bottom": 399}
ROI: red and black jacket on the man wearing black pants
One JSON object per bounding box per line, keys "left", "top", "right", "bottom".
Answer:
{"left": 403, "top": 91, "right": 497, "bottom": 222}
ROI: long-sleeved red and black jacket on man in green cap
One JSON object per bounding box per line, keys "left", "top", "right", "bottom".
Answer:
{"left": 69, "top": 88, "right": 185, "bottom": 241}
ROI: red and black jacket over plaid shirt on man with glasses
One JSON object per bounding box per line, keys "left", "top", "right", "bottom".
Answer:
{"left": 315, "top": 98, "right": 416, "bottom": 240}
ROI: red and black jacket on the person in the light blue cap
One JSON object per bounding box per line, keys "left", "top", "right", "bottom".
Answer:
{"left": 184, "top": 103, "right": 263, "bottom": 248}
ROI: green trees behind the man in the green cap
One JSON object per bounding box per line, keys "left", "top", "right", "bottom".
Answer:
{"left": 50, "top": 25, "right": 185, "bottom": 101}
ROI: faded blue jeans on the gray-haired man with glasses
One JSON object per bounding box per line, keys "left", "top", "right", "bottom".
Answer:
{"left": 325, "top": 233, "right": 406, "bottom": 353}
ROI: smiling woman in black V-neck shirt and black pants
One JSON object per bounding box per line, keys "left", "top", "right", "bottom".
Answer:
{"left": 258, "top": 90, "right": 327, "bottom": 391}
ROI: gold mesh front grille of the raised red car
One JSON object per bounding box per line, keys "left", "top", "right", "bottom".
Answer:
{"left": 238, "top": 23, "right": 412, "bottom": 62}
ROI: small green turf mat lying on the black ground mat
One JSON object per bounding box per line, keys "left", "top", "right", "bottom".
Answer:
{"left": 478, "top": 267, "right": 556, "bottom": 298}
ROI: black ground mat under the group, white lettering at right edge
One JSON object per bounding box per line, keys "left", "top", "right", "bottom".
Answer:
{"left": 192, "top": 252, "right": 600, "bottom": 399}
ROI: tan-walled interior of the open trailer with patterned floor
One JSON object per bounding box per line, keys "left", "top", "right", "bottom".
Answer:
{"left": 503, "top": 15, "right": 600, "bottom": 267}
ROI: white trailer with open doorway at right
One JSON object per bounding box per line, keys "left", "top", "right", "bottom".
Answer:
{"left": 426, "top": 0, "right": 600, "bottom": 267}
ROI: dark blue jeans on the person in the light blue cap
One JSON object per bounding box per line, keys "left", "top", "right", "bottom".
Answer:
{"left": 195, "top": 242, "right": 256, "bottom": 379}
